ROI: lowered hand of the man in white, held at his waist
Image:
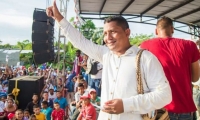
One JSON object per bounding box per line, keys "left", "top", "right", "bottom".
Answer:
{"left": 103, "top": 99, "right": 124, "bottom": 114}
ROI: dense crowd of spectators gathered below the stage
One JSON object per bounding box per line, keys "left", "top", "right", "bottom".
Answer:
{"left": 0, "top": 50, "right": 103, "bottom": 120}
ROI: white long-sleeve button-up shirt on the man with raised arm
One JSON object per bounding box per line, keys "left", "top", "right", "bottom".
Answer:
{"left": 59, "top": 19, "right": 172, "bottom": 120}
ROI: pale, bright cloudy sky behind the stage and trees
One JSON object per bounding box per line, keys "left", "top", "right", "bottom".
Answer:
{"left": 0, "top": 0, "right": 191, "bottom": 44}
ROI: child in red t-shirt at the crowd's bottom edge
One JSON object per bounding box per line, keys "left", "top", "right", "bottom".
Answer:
{"left": 51, "top": 102, "right": 65, "bottom": 120}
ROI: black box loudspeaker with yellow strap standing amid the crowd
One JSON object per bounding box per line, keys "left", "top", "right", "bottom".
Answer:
{"left": 8, "top": 76, "right": 44, "bottom": 110}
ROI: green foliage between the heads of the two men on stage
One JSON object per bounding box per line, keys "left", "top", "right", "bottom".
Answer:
{"left": 129, "top": 34, "right": 154, "bottom": 46}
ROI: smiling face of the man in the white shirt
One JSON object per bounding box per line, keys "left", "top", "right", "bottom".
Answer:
{"left": 104, "top": 21, "right": 130, "bottom": 54}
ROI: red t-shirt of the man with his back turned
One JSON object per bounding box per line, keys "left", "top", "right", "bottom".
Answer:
{"left": 140, "top": 38, "right": 199, "bottom": 113}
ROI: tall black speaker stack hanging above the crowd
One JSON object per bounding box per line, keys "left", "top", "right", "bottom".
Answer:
{"left": 32, "top": 8, "right": 55, "bottom": 64}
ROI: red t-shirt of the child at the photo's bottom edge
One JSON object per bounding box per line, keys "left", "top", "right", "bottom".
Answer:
{"left": 51, "top": 109, "right": 65, "bottom": 120}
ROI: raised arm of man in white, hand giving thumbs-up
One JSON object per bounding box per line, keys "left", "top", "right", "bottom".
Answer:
{"left": 46, "top": 0, "right": 108, "bottom": 62}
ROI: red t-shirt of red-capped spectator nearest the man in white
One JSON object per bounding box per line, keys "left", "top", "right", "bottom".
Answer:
{"left": 80, "top": 104, "right": 97, "bottom": 120}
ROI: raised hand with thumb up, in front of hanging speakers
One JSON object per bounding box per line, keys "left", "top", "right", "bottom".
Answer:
{"left": 46, "top": 0, "right": 63, "bottom": 22}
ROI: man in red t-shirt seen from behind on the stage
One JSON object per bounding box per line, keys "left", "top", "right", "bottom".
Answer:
{"left": 140, "top": 17, "right": 200, "bottom": 120}
